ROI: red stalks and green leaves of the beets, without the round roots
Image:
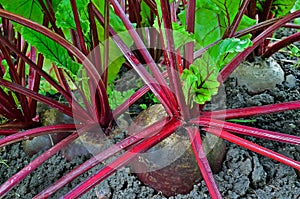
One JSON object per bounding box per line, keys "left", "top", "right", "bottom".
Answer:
{"left": 0, "top": 0, "right": 300, "bottom": 198}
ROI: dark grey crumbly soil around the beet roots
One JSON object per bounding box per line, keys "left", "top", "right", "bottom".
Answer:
{"left": 0, "top": 28, "right": 300, "bottom": 199}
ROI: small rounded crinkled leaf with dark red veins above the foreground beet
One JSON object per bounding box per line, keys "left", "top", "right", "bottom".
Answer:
{"left": 181, "top": 53, "right": 219, "bottom": 107}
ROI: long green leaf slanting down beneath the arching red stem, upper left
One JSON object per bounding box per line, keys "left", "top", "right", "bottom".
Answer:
{"left": 22, "top": 27, "right": 80, "bottom": 78}
